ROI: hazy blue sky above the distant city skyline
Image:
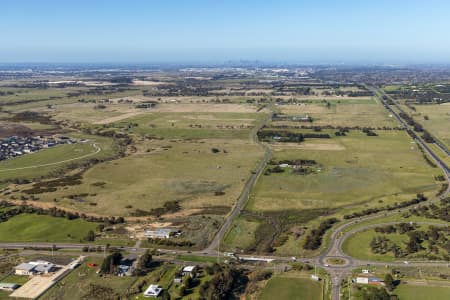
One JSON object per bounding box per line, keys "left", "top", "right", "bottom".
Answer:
{"left": 0, "top": 0, "right": 450, "bottom": 63}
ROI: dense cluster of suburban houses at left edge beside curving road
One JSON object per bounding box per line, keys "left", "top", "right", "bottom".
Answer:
{"left": 0, "top": 136, "right": 76, "bottom": 160}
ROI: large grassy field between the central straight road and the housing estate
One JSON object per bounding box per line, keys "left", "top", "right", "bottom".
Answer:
{"left": 19, "top": 139, "right": 262, "bottom": 215}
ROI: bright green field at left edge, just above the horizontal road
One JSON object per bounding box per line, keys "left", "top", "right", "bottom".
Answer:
{"left": 0, "top": 214, "right": 97, "bottom": 243}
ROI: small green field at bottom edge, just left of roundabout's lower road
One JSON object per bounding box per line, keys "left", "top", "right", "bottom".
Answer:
{"left": 259, "top": 276, "right": 322, "bottom": 300}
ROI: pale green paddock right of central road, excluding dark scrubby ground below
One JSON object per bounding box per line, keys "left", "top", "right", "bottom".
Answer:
{"left": 247, "top": 131, "right": 440, "bottom": 211}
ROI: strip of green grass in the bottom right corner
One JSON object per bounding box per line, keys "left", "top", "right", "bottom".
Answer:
{"left": 394, "top": 284, "right": 450, "bottom": 300}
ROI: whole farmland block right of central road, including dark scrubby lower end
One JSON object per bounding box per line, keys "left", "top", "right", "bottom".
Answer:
{"left": 225, "top": 130, "right": 440, "bottom": 255}
